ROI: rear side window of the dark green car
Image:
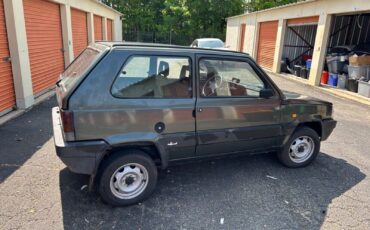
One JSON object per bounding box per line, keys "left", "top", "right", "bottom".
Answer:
{"left": 112, "top": 56, "right": 192, "bottom": 98}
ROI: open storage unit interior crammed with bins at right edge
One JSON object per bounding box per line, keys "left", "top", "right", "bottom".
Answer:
{"left": 321, "top": 12, "right": 370, "bottom": 97}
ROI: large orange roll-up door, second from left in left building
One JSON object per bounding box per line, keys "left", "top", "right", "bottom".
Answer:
{"left": 23, "top": 0, "right": 64, "bottom": 94}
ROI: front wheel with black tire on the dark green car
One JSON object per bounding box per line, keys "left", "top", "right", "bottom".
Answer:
{"left": 277, "top": 126, "right": 320, "bottom": 168}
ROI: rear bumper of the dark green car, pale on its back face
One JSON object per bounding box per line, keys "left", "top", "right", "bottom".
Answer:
{"left": 52, "top": 107, "right": 109, "bottom": 175}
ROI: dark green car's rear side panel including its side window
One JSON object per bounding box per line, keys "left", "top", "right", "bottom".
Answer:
{"left": 73, "top": 47, "right": 196, "bottom": 160}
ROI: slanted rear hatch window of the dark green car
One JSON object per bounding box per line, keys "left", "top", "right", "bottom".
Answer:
{"left": 60, "top": 45, "right": 106, "bottom": 91}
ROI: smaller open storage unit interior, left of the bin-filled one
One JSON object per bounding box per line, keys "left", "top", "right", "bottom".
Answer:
{"left": 280, "top": 21, "right": 317, "bottom": 79}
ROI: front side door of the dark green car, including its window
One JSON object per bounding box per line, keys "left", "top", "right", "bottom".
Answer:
{"left": 196, "top": 55, "right": 282, "bottom": 156}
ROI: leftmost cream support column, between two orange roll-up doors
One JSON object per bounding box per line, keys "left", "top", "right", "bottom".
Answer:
{"left": 4, "top": 0, "right": 34, "bottom": 109}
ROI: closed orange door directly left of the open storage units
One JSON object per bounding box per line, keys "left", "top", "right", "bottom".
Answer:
{"left": 257, "top": 21, "right": 278, "bottom": 69}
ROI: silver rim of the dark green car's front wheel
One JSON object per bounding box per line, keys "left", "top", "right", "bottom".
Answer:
{"left": 289, "top": 136, "right": 315, "bottom": 163}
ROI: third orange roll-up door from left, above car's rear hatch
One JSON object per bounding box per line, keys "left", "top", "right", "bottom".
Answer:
{"left": 71, "top": 9, "right": 88, "bottom": 57}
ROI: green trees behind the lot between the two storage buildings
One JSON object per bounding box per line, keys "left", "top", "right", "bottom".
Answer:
{"left": 103, "top": 0, "right": 245, "bottom": 45}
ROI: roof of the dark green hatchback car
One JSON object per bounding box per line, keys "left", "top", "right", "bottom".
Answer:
{"left": 96, "top": 42, "right": 250, "bottom": 57}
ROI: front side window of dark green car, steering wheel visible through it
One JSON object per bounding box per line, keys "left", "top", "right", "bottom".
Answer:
{"left": 199, "top": 59, "right": 265, "bottom": 97}
